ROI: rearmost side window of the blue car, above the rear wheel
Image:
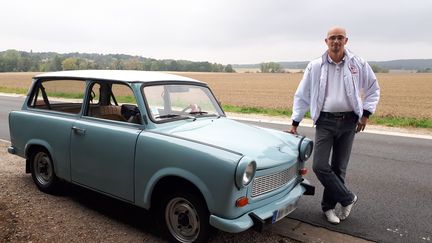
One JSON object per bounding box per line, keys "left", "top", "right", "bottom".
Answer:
{"left": 28, "top": 80, "right": 86, "bottom": 114}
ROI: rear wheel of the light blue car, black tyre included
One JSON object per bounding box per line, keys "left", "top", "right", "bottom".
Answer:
{"left": 30, "top": 149, "right": 60, "bottom": 194}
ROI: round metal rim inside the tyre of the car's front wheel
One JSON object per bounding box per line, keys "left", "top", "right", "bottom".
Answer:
{"left": 165, "top": 197, "right": 200, "bottom": 242}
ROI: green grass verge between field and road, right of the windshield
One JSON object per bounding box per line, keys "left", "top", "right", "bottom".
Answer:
{"left": 222, "top": 105, "right": 432, "bottom": 129}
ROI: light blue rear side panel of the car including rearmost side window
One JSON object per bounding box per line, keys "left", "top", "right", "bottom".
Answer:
{"left": 23, "top": 78, "right": 86, "bottom": 181}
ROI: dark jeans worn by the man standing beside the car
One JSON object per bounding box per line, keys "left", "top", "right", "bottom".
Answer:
{"left": 313, "top": 113, "right": 358, "bottom": 212}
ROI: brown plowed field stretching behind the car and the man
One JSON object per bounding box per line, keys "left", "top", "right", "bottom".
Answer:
{"left": 0, "top": 72, "right": 432, "bottom": 118}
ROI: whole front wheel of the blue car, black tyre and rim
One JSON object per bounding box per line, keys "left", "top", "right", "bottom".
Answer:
{"left": 158, "top": 191, "right": 211, "bottom": 243}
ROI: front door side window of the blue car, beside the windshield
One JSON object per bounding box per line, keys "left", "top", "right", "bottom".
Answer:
{"left": 85, "top": 81, "right": 141, "bottom": 124}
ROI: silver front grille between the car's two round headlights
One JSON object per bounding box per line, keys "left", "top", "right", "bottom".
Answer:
{"left": 252, "top": 165, "right": 297, "bottom": 197}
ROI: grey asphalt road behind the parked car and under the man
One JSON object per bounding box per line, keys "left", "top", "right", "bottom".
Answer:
{"left": 0, "top": 96, "right": 432, "bottom": 242}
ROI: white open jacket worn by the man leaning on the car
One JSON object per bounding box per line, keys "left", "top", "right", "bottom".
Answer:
{"left": 291, "top": 49, "right": 380, "bottom": 123}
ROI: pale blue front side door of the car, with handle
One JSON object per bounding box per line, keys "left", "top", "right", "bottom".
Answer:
{"left": 71, "top": 81, "right": 142, "bottom": 202}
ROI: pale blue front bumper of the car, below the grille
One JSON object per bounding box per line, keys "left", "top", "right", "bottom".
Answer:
{"left": 210, "top": 179, "right": 315, "bottom": 233}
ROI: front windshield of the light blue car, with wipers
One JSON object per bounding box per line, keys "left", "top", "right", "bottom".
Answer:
{"left": 143, "top": 84, "right": 223, "bottom": 122}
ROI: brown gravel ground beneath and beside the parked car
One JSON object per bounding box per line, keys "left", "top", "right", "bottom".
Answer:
{"left": 0, "top": 141, "right": 294, "bottom": 243}
